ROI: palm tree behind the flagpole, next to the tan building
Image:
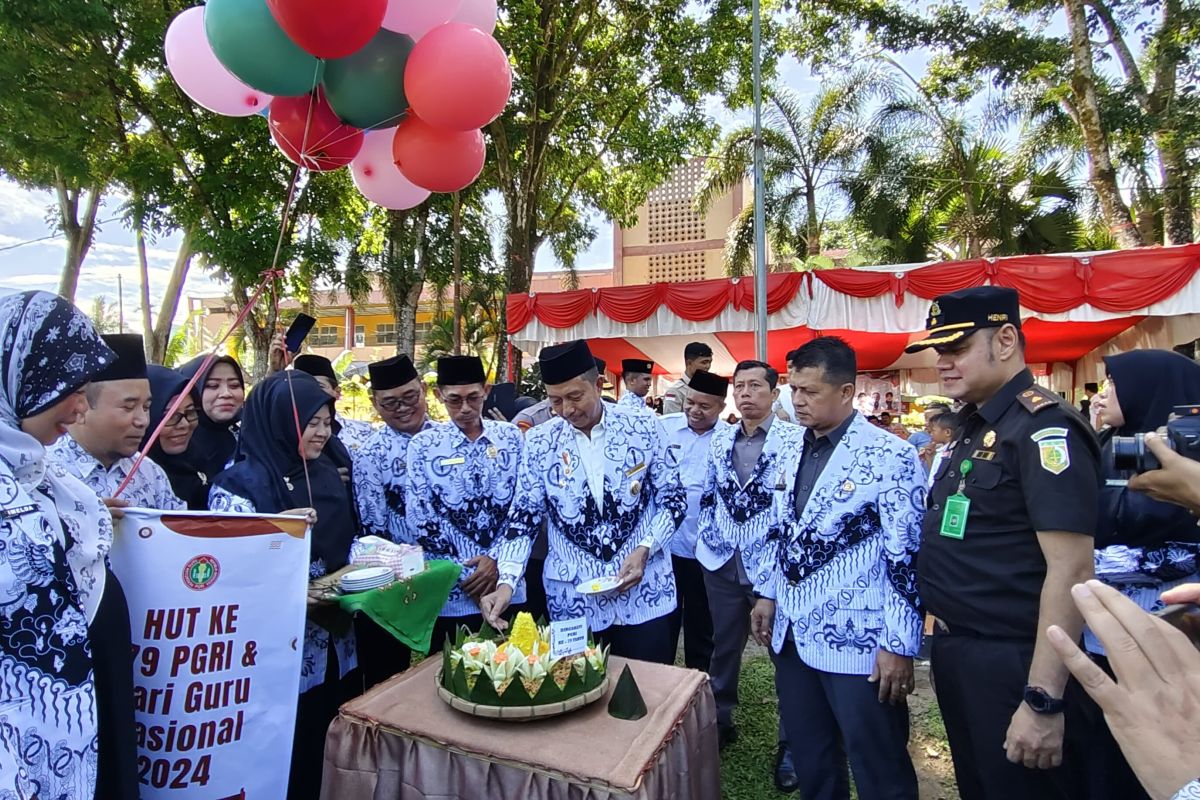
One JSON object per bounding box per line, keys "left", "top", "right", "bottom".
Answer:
{"left": 696, "top": 70, "right": 890, "bottom": 275}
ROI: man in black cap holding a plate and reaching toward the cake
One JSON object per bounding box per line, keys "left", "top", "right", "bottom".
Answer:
{"left": 480, "top": 341, "right": 686, "bottom": 663}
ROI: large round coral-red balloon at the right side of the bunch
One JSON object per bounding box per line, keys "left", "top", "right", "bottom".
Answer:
{"left": 404, "top": 23, "right": 512, "bottom": 131}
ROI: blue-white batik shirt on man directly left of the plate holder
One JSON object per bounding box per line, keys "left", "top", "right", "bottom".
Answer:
{"left": 406, "top": 420, "right": 524, "bottom": 618}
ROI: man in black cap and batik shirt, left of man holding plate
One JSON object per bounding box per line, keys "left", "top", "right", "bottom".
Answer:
{"left": 406, "top": 355, "right": 524, "bottom": 650}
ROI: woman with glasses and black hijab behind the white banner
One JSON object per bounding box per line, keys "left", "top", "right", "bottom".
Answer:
{"left": 142, "top": 365, "right": 209, "bottom": 511}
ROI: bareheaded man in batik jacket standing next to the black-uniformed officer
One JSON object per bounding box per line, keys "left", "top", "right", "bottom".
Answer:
{"left": 751, "top": 337, "right": 926, "bottom": 800}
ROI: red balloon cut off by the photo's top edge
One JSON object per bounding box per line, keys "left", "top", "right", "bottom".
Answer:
{"left": 266, "top": 0, "right": 388, "bottom": 59}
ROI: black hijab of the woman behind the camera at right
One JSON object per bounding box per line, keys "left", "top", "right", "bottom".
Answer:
{"left": 1104, "top": 350, "right": 1200, "bottom": 437}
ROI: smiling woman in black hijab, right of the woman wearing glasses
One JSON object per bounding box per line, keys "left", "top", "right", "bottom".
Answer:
{"left": 179, "top": 355, "right": 246, "bottom": 481}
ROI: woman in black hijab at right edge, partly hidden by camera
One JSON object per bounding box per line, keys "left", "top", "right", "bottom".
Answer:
{"left": 1084, "top": 350, "right": 1200, "bottom": 800}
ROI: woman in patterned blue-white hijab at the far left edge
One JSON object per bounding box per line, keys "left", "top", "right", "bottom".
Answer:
{"left": 0, "top": 291, "right": 137, "bottom": 800}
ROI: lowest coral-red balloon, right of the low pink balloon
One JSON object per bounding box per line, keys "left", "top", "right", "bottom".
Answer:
{"left": 393, "top": 115, "right": 487, "bottom": 192}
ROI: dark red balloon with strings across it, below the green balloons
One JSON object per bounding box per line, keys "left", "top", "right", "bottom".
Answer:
{"left": 268, "top": 88, "right": 362, "bottom": 173}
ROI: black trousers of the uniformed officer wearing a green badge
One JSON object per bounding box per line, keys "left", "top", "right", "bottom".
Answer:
{"left": 932, "top": 633, "right": 1088, "bottom": 800}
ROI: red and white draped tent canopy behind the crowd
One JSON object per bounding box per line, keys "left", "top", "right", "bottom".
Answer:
{"left": 508, "top": 245, "right": 1200, "bottom": 391}
